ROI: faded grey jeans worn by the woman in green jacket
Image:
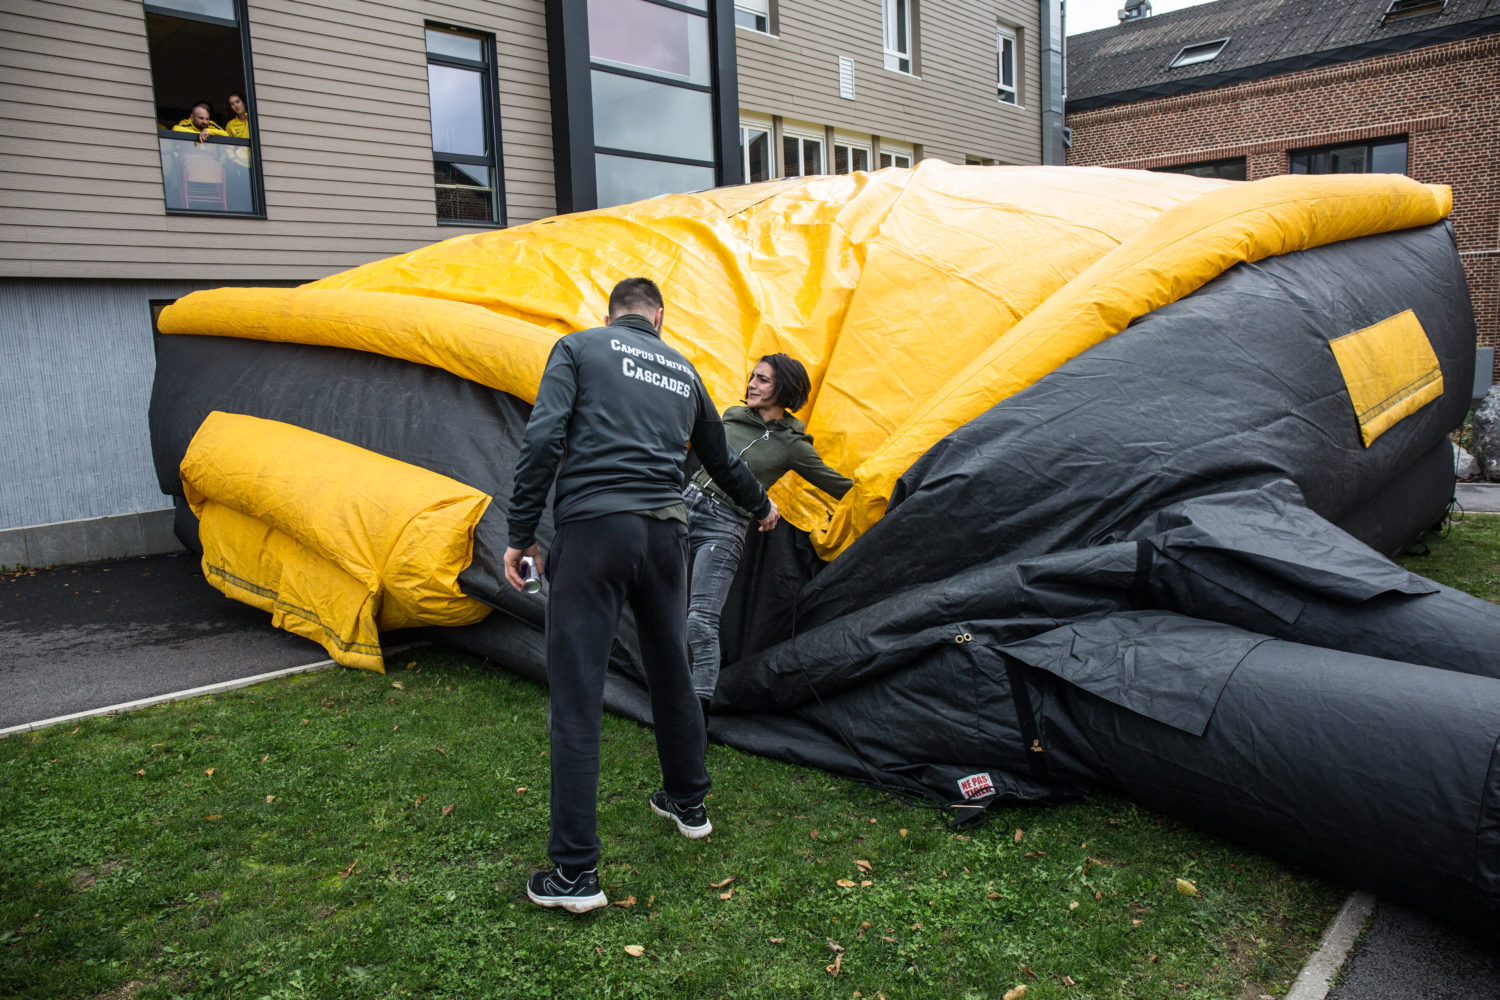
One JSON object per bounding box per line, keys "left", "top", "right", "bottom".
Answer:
{"left": 683, "top": 486, "right": 750, "bottom": 699}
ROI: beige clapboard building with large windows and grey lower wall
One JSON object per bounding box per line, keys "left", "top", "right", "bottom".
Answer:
{"left": 0, "top": 0, "right": 1062, "bottom": 567}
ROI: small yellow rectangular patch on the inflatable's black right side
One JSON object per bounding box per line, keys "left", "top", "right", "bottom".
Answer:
{"left": 1329, "top": 309, "right": 1443, "bottom": 448}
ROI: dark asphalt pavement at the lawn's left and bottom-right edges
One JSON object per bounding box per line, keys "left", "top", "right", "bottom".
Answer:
{"left": 0, "top": 483, "right": 1500, "bottom": 1000}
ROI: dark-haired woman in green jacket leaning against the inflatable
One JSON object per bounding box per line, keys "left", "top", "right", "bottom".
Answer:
{"left": 683, "top": 354, "right": 854, "bottom": 712}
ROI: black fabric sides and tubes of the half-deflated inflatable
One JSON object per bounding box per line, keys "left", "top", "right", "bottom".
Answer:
{"left": 143, "top": 206, "right": 1500, "bottom": 927}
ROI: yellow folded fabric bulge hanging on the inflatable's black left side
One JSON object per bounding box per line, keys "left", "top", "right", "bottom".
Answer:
{"left": 182, "top": 411, "right": 491, "bottom": 673}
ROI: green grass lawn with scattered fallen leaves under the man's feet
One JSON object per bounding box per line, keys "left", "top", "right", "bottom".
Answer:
{"left": 0, "top": 516, "right": 1500, "bottom": 1000}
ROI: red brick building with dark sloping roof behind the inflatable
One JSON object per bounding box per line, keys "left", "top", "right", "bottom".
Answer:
{"left": 1067, "top": 0, "right": 1500, "bottom": 379}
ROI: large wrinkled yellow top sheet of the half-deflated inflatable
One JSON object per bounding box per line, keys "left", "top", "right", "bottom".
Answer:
{"left": 161, "top": 160, "right": 1451, "bottom": 558}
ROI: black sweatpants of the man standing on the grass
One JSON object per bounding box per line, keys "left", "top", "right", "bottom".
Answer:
{"left": 546, "top": 513, "right": 710, "bottom": 868}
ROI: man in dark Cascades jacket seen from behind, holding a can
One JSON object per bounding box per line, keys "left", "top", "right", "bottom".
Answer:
{"left": 506, "top": 277, "right": 779, "bottom": 913}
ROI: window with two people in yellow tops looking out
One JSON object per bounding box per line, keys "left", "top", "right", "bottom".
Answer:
{"left": 144, "top": 0, "right": 266, "bottom": 216}
